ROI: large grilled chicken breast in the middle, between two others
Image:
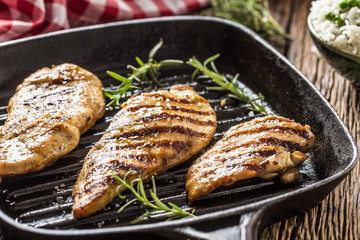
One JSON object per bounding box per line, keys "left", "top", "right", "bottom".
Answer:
{"left": 73, "top": 85, "right": 216, "bottom": 218}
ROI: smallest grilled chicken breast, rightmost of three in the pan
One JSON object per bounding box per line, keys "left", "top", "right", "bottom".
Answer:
{"left": 186, "top": 116, "right": 315, "bottom": 204}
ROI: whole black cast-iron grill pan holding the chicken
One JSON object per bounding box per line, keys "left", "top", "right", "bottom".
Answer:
{"left": 0, "top": 17, "right": 357, "bottom": 239}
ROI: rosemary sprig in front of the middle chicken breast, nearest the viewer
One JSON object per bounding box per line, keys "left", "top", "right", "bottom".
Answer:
{"left": 112, "top": 171, "right": 195, "bottom": 224}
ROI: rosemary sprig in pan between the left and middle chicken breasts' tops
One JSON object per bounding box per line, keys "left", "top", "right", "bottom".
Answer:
{"left": 103, "top": 39, "right": 184, "bottom": 106}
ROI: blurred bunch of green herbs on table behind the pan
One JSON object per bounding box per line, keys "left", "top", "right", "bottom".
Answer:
{"left": 203, "top": 0, "right": 290, "bottom": 39}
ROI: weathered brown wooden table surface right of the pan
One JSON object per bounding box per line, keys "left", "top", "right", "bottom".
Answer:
{"left": 260, "top": 0, "right": 360, "bottom": 240}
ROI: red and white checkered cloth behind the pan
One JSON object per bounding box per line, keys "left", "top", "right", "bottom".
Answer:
{"left": 0, "top": 0, "right": 210, "bottom": 42}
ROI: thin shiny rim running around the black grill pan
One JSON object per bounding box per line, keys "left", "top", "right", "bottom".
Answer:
{"left": 0, "top": 16, "right": 358, "bottom": 237}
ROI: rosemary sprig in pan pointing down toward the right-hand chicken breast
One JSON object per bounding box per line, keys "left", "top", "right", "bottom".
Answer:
{"left": 186, "top": 54, "right": 269, "bottom": 115}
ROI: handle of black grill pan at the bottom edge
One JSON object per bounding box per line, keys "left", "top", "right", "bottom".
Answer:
{"left": 160, "top": 207, "right": 268, "bottom": 240}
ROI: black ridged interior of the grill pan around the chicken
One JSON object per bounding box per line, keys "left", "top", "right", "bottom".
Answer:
{"left": 0, "top": 18, "right": 355, "bottom": 238}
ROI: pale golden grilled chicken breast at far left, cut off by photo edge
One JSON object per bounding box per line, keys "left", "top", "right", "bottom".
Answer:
{"left": 0, "top": 63, "right": 105, "bottom": 176}
